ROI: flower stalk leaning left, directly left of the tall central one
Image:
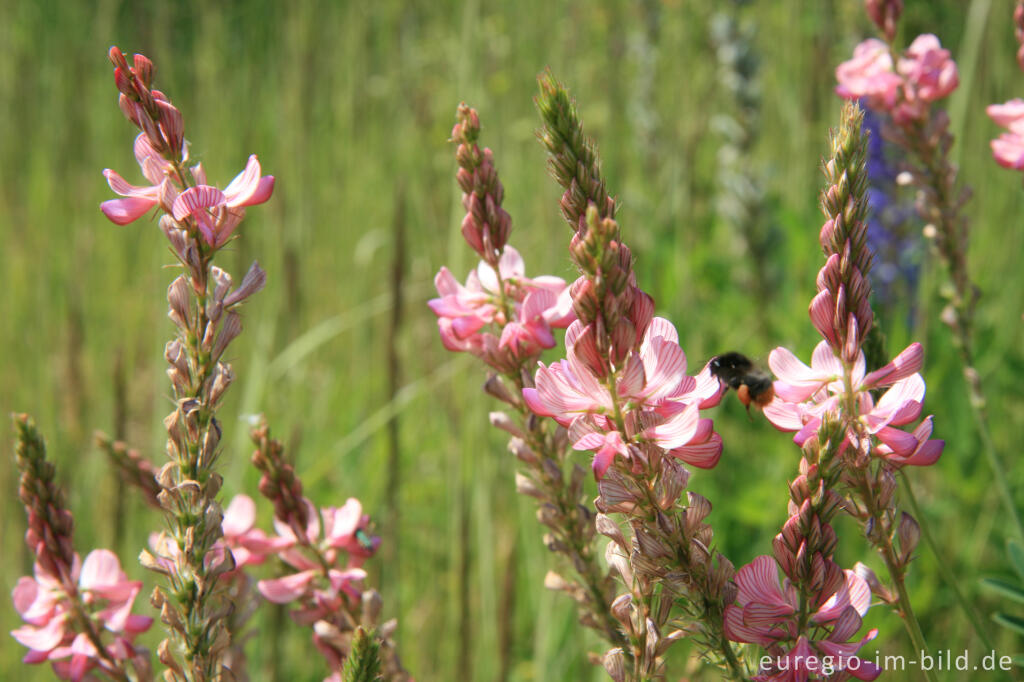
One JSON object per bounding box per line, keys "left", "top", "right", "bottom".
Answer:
{"left": 430, "top": 104, "right": 626, "bottom": 646}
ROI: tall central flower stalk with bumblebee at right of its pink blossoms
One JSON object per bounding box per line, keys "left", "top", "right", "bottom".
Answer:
{"left": 523, "top": 73, "right": 745, "bottom": 682}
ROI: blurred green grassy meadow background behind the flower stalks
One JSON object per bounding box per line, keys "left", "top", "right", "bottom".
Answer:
{"left": 0, "top": 0, "right": 1024, "bottom": 681}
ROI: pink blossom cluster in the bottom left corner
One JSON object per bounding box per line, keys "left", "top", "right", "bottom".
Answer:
{"left": 11, "top": 550, "right": 153, "bottom": 682}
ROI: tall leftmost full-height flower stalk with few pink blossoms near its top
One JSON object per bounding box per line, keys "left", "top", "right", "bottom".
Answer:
{"left": 101, "top": 47, "right": 273, "bottom": 682}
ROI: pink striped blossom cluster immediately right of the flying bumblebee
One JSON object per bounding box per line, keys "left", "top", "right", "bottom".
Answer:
{"left": 764, "top": 341, "right": 945, "bottom": 466}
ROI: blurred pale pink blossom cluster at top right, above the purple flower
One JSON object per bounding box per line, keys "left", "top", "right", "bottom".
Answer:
{"left": 836, "top": 34, "right": 959, "bottom": 124}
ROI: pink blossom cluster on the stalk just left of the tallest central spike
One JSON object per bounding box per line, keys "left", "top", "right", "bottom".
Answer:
{"left": 429, "top": 246, "right": 575, "bottom": 371}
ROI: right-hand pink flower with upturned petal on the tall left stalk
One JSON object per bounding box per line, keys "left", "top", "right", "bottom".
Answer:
{"left": 171, "top": 154, "right": 273, "bottom": 248}
